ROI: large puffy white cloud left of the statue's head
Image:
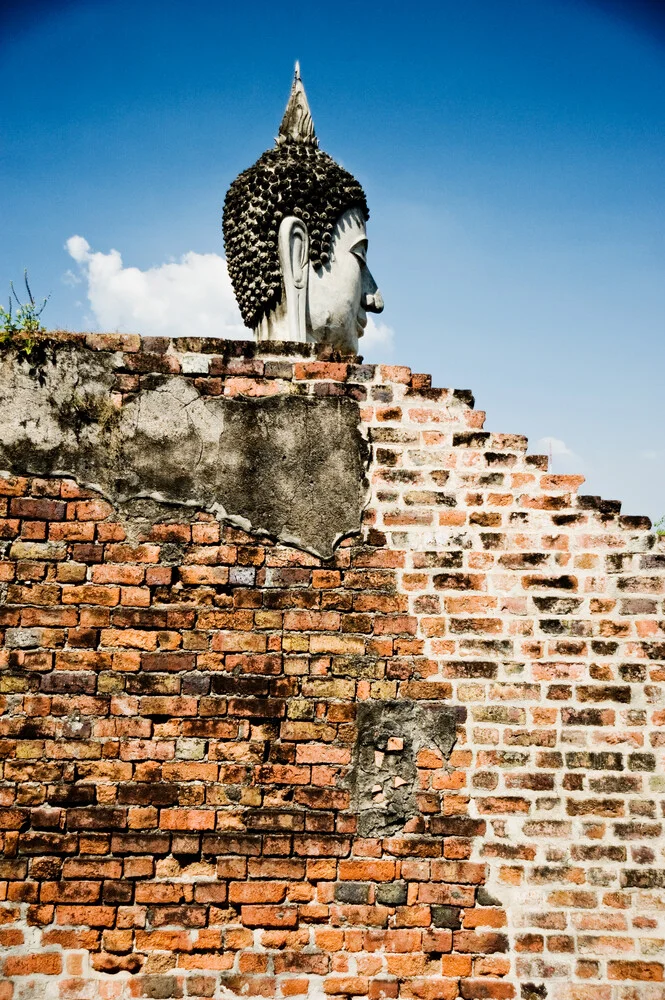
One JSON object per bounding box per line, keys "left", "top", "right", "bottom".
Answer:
{"left": 66, "top": 236, "right": 252, "bottom": 340}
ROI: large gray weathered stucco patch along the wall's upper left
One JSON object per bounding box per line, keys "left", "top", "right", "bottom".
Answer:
{"left": 0, "top": 344, "right": 368, "bottom": 558}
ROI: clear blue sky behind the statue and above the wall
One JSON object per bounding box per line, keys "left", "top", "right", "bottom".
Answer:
{"left": 0, "top": 0, "right": 665, "bottom": 517}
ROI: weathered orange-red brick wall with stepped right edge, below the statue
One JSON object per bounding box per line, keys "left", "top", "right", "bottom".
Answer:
{"left": 0, "top": 335, "right": 665, "bottom": 1000}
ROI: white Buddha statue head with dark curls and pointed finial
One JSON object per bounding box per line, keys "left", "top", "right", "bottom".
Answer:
{"left": 223, "top": 63, "right": 383, "bottom": 353}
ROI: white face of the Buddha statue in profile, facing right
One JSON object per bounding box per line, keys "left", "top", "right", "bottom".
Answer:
{"left": 307, "top": 208, "right": 383, "bottom": 353}
